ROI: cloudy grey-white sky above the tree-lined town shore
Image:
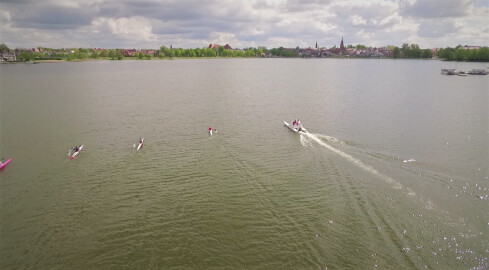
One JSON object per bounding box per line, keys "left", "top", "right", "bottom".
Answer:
{"left": 0, "top": 0, "right": 489, "bottom": 48}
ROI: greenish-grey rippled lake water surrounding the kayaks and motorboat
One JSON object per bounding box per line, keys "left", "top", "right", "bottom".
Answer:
{"left": 0, "top": 59, "right": 489, "bottom": 269}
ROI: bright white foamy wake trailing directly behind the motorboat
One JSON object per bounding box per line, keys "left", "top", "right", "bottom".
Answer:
{"left": 301, "top": 133, "right": 408, "bottom": 192}
